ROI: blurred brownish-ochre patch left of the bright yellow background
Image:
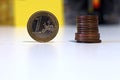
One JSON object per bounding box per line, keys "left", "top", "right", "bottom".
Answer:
{"left": 0, "top": 0, "right": 14, "bottom": 26}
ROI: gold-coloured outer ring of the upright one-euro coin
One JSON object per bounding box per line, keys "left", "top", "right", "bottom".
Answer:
{"left": 27, "top": 11, "right": 59, "bottom": 42}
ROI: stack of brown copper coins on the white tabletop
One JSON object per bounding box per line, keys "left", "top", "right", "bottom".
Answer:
{"left": 75, "top": 15, "right": 101, "bottom": 43}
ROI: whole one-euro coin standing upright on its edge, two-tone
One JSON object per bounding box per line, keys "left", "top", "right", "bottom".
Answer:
{"left": 27, "top": 11, "right": 59, "bottom": 42}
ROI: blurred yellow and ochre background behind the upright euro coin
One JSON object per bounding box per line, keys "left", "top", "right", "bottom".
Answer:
{"left": 0, "top": 0, "right": 64, "bottom": 27}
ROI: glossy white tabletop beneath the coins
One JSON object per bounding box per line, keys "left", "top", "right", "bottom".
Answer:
{"left": 0, "top": 25, "right": 120, "bottom": 80}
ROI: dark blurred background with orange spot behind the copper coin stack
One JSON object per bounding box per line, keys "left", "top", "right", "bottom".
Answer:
{"left": 64, "top": 0, "right": 120, "bottom": 25}
